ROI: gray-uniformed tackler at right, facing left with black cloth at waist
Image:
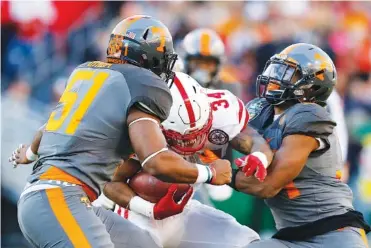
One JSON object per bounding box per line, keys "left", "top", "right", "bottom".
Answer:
{"left": 232, "top": 43, "right": 369, "bottom": 248}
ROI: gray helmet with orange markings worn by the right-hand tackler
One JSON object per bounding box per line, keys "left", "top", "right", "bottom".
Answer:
{"left": 256, "top": 43, "right": 336, "bottom": 105}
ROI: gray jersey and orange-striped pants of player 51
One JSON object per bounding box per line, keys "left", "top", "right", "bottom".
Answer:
{"left": 18, "top": 61, "right": 172, "bottom": 248}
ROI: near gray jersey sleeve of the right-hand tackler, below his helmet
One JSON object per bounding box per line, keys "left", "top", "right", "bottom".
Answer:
{"left": 283, "top": 104, "right": 336, "bottom": 150}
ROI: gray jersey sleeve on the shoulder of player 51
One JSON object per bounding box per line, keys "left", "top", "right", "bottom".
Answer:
{"left": 117, "top": 64, "right": 172, "bottom": 122}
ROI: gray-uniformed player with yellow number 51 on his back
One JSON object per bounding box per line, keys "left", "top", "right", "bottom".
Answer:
{"left": 10, "top": 16, "right": 231, "bottom": 248}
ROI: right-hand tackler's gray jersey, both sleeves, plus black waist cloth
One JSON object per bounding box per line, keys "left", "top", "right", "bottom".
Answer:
{"left": 247, "top": 99, "right": 370, "bottom": 247}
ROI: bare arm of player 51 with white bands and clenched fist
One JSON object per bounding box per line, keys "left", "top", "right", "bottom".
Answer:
{"left": 127, "top": 108, "right": 232, "bottom": 185}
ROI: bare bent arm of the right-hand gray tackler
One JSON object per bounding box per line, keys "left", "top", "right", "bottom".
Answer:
{"left": 234, "top": 134, "right": 319, "bottom": 198}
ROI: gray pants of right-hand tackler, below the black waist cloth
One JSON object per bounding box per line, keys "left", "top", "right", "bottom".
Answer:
{"left": 246, "top": 227, "right": 368, "bottom": 248}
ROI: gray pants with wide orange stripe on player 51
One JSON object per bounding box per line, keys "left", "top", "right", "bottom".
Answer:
{"left": 18, "top": 186, "right": 157, "bottom": 248}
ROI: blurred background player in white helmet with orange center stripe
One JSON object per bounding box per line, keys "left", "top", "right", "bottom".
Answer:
{"left": 182, "top": 28, "right": 242, "bottom": 97}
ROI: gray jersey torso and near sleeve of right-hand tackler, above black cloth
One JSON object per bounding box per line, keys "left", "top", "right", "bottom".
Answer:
{"left": 265, "top": 101, "right": 353, "bottom": 230}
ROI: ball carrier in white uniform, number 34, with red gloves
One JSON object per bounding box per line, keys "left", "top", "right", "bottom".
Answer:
{"left": 101, "top": 72, "right": 272, "bottom": 248}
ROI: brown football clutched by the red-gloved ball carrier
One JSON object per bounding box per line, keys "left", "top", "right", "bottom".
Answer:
{"left": 129, "top": 171, "right": 191, "bottom": 203}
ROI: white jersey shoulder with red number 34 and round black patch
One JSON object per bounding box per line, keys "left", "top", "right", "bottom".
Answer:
{"left": 205, "top": 89, "right": 249, "bottom": 156}
